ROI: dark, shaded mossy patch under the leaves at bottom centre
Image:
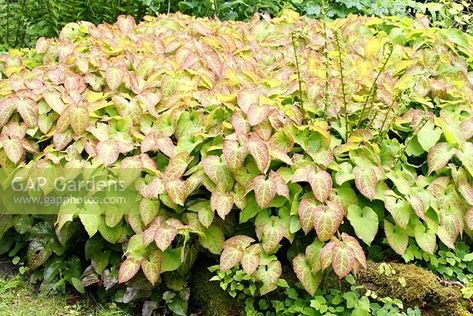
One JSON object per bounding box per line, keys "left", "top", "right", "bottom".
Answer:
{"left": 190, "top": 258, "right": 242, "bottom": 316}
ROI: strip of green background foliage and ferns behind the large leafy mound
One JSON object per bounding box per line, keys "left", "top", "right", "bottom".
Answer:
{"left": 0, "top": 0, "right": 472, "bottom": 50}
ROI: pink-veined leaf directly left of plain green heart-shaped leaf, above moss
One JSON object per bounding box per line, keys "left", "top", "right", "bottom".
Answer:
{"left": 313, "top": 205, "right": 341, "bottom": 241}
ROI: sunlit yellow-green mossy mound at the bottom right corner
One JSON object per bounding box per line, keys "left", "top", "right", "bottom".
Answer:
{"left": 357, "top": 262, "right": 472, "bottom": 316}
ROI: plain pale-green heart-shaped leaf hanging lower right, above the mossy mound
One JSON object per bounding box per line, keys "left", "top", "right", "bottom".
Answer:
{"left": 347, "top": 204, "right": 379, "bottom": 246}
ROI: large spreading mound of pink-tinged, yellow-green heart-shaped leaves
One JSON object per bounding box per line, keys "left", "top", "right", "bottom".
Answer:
{"left": 0, "top": 11, "right": 473, "bottom": 315}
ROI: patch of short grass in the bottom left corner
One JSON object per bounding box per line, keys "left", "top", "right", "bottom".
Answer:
{"left": 0, "top": 275, "right": 129, "bottom": 316}
